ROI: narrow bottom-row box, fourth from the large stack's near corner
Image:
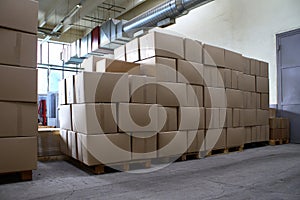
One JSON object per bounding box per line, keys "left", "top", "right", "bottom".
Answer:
{"left": 187, "top": 130, "right": 205, "bottom": 153}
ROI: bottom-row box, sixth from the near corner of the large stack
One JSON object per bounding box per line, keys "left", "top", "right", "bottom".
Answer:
{"left": 226, "top": 127, "right": 245, "bottom": 148}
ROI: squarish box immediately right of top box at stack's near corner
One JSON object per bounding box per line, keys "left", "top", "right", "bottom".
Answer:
{"left": 128, "top": 75, "right": 156, "bottom": 104}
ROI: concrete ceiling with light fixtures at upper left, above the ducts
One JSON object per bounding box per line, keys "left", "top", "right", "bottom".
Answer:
{"left": 38, "top": 0, "right": 165, "bottom": 42}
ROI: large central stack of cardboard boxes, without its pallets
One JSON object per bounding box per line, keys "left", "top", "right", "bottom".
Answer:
{"left": 60, "top": 28, "right": 269, "bottom": 165}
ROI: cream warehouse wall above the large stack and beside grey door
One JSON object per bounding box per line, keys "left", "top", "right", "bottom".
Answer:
{"left": 167, "top": 0, "right": 300, "bottom": 104}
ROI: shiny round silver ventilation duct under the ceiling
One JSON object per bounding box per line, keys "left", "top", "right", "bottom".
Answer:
{"left": 123, "top": 0, "right": 213, "bottom": 33}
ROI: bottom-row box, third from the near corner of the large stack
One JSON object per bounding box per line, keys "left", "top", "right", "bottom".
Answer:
{"left": 157, "top": 131, "right": 187, "bottom": 158}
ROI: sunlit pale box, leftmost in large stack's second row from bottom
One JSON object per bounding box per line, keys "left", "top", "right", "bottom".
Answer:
{"left": 58, "top": 105, "right": 72, "bottom": 130}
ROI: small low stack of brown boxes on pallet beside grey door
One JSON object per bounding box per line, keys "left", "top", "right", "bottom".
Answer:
{"left": 269, "top": 108, "right": 290, "bottom": 145}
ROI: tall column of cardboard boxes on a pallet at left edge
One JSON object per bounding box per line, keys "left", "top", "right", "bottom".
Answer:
{"left": 0, "top": 0, "right": 38, "bottom": 180}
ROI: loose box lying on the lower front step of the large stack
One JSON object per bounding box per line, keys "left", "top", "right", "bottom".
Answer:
{"left": 96, "top": 58, "right": 141, "bottom": 75}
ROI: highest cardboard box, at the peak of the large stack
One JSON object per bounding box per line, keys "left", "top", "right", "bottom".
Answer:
{"left": 140, "top": 31, "right": 184, "bottom": 60}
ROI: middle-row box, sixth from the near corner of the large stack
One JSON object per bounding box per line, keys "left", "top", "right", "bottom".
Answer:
{"left": 226, "top": 89, "right": 244, "bottom": 108}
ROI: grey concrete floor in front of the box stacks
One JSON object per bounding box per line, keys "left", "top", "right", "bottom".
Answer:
{"left": 0, "top": 144, "right": 300, "bottom": 200}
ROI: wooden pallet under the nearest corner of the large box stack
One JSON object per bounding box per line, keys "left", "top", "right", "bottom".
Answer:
{"left": 67, "top": 157, "right": 151, "bottom": 175}
